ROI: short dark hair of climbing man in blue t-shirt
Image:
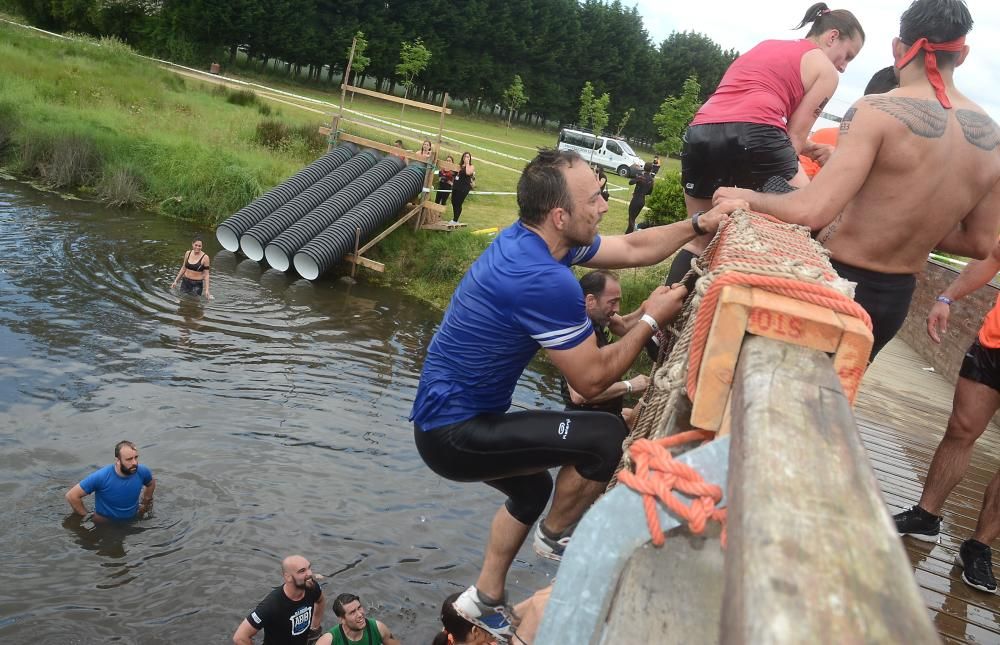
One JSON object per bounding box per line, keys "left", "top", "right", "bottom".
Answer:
{"left": 517, "top": 148, "right": 583, "bottom": 226}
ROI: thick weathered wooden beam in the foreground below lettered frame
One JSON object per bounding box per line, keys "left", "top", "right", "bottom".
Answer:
{"left": 720, "top": 336, "right": 939, "bottom": 645}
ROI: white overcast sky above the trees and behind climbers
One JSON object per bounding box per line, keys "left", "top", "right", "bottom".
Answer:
{"left": 636, "top": 0, "right": 1000, "bottom": 127}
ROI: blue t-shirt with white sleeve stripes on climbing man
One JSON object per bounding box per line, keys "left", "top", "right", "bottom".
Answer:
{"left": 410, "top": 221, "right": 601, "bottom": 430}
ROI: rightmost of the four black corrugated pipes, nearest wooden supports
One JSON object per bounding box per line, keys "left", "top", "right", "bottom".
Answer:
{"left": 295, "top": 164, "right": 424, "bottom": 280}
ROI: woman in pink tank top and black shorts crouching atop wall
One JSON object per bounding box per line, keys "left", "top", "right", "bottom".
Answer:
{"left": 668, "top": 2, "right": 865, "bottom": 284}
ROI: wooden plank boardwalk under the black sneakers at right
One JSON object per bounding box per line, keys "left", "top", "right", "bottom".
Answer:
{"left": 860, "top": 339, "right": 1000, "bottom": 643}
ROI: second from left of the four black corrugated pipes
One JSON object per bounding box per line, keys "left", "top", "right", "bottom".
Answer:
{"left": 240, "top": 150, "right": 378, "bottom": 261}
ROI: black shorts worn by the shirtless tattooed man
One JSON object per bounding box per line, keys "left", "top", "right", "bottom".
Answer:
{"left": 830, "top": 259, "right": 917, "bottom": 363}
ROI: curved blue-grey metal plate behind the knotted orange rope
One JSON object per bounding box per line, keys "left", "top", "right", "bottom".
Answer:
{"left": 535, "top": 437, "right": 730, "bottom": 645}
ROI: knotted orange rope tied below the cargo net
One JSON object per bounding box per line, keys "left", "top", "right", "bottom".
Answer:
{"left": 618, "top": 430, "right": 726, "bottom": 547}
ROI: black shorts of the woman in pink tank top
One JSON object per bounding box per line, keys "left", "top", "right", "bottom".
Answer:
{"left": 681, "top": 123, "right": 799, "bottom": 199}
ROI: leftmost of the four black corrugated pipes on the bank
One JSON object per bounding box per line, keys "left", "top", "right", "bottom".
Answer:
{"left": 215, "top": 144, "right": 358, "bottom": 252}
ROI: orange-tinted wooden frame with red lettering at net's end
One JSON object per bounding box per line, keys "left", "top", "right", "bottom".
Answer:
{"left": 691, "top": 285, "right": 872, "bottom": 430}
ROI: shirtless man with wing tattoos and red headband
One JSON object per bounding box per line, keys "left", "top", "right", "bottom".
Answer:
{"left": 714, "top": 0, "right": 1000, "bottom": 360}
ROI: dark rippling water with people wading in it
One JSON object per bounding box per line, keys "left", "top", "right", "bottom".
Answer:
{"left": 0, "top": 182, "right": 558, "bottom": 643}
